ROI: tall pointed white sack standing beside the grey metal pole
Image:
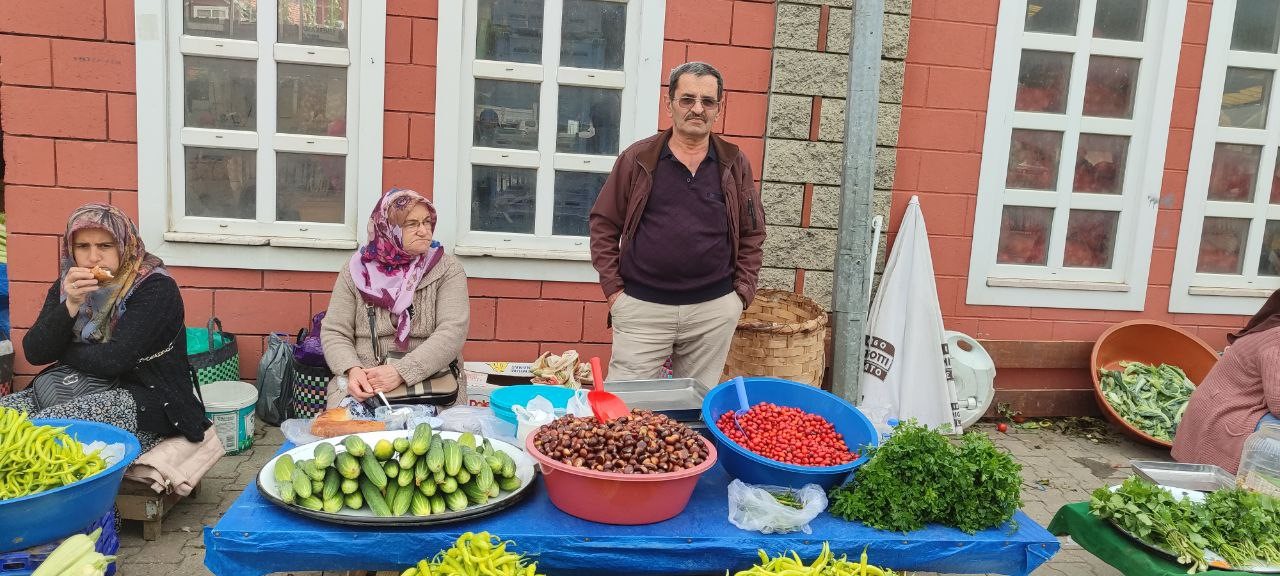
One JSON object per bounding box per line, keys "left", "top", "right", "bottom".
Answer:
{"left": 858, "top": 196, "right": 961, "bottom": 434}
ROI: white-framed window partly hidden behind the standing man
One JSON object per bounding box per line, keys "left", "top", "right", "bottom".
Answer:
{"left": 434, "top": 0, "right": 666, "bottom": 282}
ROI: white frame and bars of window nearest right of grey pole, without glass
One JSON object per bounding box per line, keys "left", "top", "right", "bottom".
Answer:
{"left": 966, "top": 0, "right": 1187, "bottom": 310}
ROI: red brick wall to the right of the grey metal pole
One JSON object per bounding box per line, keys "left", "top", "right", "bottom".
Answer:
{"left": 891, "top": 0, "right": 1244, "bottom": 411}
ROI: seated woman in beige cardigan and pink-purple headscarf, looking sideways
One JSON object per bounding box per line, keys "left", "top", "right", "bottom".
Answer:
{"left": 320, "top": 188, "right": 471, "bottom": 407}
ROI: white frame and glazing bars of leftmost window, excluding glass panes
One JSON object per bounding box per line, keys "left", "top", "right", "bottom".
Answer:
{"left": 134, "top": 0, "right": 387, "bottom": 271}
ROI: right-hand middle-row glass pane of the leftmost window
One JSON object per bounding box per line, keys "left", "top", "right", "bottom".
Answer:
{"left": 275, "top": 64, "right": 347, "bottom": 136}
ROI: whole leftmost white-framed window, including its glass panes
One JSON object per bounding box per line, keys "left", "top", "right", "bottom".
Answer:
{"left": 134, "top": 0, "right": 387, "bottom": 270}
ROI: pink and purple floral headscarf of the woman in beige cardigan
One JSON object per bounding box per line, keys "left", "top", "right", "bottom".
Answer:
{"left": 349, "top": 188, "right": 444, "bottom": 351}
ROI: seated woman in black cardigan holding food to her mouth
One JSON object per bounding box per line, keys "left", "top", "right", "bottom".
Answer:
{"left": 0, "top": 204, "right": 209, "bottom": 452}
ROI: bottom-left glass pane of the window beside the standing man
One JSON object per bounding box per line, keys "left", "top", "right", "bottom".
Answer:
{"left": 471, "top": 166, "right": 538, "bottom": 234}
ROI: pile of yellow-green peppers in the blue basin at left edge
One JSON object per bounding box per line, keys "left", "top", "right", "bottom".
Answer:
{"left": 0, "top": 407, "right": 106, "bottom": 500}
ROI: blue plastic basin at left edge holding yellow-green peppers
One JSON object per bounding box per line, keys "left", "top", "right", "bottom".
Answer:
{"left": 0, "top": 419, "right": 142, "bottom": 552}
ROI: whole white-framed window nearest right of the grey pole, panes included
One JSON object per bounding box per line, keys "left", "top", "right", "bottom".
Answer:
{"left": 966, "top": 0, "right": 1187, "bottom": 310}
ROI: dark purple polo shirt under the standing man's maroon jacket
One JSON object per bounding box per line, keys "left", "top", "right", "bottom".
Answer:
{"left": 620, "top": 145, "right": 733, "bottom": 305}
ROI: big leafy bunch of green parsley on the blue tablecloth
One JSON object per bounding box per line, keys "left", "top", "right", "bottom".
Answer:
{"left": 828, "top": 420, "right": 1023, "bottom": 534}
